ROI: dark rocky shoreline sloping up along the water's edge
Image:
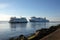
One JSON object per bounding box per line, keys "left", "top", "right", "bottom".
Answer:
{"left": 9, "top": 24, "right": 60, "bottom": 40}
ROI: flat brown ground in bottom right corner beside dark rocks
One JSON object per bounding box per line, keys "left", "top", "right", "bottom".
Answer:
{"left": 40, "top": 29, "right": 60, "bottom": 40}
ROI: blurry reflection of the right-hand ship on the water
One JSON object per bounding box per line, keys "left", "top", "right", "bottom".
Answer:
{"left": 30, "top": 22, "right": 47, "bottom": 30}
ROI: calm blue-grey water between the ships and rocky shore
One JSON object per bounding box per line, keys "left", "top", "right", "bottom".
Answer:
{"left": 0, "top": 22, "right": 60, "bottom": 40}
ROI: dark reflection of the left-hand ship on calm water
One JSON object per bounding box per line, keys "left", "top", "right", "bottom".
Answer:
{"left": 10, "top": 23, "right": 27, "bottom": 31}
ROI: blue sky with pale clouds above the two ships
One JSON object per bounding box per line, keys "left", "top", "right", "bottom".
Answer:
{"left": 0, "top": 0, "right": 60, "bottom": 21}
